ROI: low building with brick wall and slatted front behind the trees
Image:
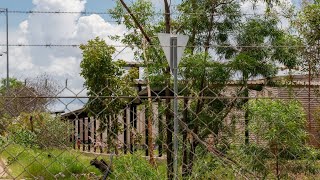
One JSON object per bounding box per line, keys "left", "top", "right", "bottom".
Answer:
{"left": 62, "top": 75, "right": 320, "bottom": 155}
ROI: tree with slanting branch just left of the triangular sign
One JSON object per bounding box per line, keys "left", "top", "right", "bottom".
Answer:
{"left": 109, "top": 0, "right": 173, "bottom": 174}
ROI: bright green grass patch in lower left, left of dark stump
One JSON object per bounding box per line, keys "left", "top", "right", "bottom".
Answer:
{"left": 0, "top": 145, "right": 101, "bottom": 179}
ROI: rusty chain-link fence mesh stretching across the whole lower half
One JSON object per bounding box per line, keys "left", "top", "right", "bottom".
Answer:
{"left": 0, "top": 75, "right": 320, "bottom": 179}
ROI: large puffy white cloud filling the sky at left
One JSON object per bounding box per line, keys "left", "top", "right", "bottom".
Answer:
{"left": 0, "top": 0, "right": 133, "bottom": 111}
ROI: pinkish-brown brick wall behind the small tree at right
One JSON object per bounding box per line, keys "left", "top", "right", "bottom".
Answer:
{"left": 224, "top": 86, "right": 320, "bottom": 147}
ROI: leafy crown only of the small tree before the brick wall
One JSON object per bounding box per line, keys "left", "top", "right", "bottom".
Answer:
{"left": 249, "top": 100, "right": 307, "bottom": 148}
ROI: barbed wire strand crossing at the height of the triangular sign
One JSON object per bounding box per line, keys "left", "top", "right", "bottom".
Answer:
{"left": 0, "top": 44, "right": 314, "bottom": 48}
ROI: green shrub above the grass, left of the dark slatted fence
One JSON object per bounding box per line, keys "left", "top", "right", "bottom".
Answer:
{"left": 6, "top": 112, "right": 71, "bottom": 148}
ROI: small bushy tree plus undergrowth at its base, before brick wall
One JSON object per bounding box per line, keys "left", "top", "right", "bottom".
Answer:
{"left": 246, "top": 99, "right": 320, "bottom": 179}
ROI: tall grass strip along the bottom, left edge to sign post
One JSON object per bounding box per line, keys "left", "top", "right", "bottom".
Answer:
{"left": 0, "top": 145, "right": 166, "bottom": 180}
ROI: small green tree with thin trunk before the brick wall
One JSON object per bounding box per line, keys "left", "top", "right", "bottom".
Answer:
{"left": 249, "top": 99, "right": 307, "bottom": 179}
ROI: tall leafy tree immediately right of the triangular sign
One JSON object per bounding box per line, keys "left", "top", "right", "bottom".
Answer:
{"left": 173, "top": 0, "right": 240, "bottom": 176}
